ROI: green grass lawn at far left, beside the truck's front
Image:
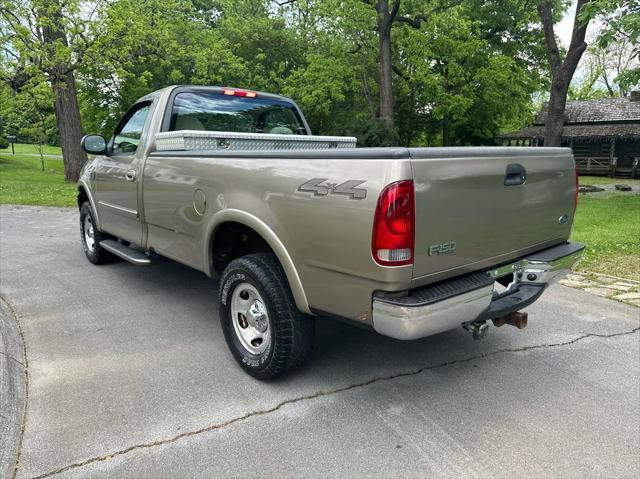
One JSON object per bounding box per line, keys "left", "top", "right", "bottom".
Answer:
{"left": 0, "top": 152, "right": 76, "bottom": 206}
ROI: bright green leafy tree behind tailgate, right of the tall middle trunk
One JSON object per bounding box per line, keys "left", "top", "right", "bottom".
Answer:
{"left": 396, "top": 7, "right": 538, "bottom": 146}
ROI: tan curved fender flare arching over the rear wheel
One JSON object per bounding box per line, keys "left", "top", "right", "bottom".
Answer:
{"left": 203, "top": 208, "right": 312, "bottom": 314}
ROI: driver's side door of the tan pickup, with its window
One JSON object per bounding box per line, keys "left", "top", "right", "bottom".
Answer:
{"left": 95, "top": 102, "right": 151, "bottom": 245}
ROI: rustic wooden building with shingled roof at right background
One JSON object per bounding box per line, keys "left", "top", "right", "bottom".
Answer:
{"left": 498, "top": 91, "right": 640, "bottom": 178}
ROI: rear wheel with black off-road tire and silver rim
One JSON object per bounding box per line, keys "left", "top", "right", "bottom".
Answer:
{"left": 219, "top": 253, "right": 315, "bottom": 379}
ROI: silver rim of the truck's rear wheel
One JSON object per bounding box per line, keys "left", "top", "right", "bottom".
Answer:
{"left": 231, "top": 283, "right": 271, "bottom": 354}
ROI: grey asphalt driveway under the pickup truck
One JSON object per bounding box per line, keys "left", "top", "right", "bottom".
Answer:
{"left": 0, "top": 206, "right": 640, "bottom": 478}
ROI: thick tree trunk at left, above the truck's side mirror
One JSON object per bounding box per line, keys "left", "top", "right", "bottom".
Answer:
{"left": 37, "top": 0, "right": 87, "bottom": 182}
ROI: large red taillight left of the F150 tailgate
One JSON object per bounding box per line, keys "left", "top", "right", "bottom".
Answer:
{"left": 371, "top": 180, "right": 416, "bottom": 266}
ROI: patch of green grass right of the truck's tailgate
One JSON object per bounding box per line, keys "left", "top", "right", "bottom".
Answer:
{"left": 571, "top": 193, "right": 640, "bottom": 280}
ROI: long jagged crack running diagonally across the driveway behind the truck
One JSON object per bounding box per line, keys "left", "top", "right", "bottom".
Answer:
{"left": 32, "top": 326, "right": 640, "bottom": 479}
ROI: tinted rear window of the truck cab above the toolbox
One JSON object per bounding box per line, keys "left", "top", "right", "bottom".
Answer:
{"left": 169, "top": 91, "right": 307, "bottom": 135}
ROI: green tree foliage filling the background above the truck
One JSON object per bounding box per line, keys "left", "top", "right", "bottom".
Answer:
{"left": 0, "top": 0, "right": 639, "bottom": 146}
